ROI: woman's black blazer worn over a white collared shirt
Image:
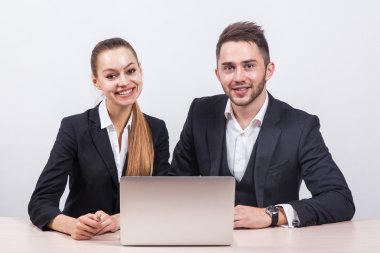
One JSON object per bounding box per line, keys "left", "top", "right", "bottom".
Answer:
{"left": 28, "top": 107, "right": 170, "bottom": 229}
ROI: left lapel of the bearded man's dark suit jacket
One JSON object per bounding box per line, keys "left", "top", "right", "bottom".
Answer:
{"left": 207, "top": 97, "right": 227, "bottom": 176}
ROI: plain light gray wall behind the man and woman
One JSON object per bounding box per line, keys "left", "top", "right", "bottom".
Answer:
{"left": 0, "top": 0, "right": 380, "bottom": 219}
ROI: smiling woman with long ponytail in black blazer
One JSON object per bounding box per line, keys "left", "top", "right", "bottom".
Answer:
{"left": 28, "top": 38, "right": 169, "bottom": 240}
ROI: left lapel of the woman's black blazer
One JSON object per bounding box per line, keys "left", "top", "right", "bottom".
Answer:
{"left": 90, "top": 108, "right": 119, "bottom": 187}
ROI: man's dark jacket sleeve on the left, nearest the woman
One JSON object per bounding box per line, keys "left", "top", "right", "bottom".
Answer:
{"left": 169, "top": 99, "right": 199, "bottom": 176}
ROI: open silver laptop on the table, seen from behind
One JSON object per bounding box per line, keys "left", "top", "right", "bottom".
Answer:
{"left": 120, "top": 176, "right": 235, "bottom": 245}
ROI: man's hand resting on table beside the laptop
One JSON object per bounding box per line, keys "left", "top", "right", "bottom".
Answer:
{"left": 234, "top": 205, "right": 272, "bottom": 228}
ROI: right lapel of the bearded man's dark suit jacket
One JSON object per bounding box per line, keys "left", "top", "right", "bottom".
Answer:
{"left": 254, "top": 93, "right": 281, "bottom": 207}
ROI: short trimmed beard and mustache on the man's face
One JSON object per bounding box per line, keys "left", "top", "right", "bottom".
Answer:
{"left": 224, "top": 77, "right": 266, "bottom": 106}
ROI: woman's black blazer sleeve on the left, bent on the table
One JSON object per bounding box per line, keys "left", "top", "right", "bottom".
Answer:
{"left": 28, "top": 118, "right": 77, "bottom": 230}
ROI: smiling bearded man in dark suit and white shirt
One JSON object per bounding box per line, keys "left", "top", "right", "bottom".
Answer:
{"left": 171, "top": 22, "right": 355, "bottom": 228}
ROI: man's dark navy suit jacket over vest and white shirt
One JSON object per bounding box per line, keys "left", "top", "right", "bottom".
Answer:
{"left": 170, "top": 95, "right": 355, "bottom": 226}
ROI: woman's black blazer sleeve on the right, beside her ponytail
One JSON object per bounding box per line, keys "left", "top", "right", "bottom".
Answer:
{"left": 153, "top": 120, "right": 170, "bottom": 176}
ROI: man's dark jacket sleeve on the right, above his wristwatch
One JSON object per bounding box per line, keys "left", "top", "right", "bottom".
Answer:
{"left": 289, "top": 116, "right": 355, "bottom": 227}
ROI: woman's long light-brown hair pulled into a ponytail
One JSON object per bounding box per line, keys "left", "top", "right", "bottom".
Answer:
{"left": 91, "top": 38, "right": 154, "bottom": 176}
